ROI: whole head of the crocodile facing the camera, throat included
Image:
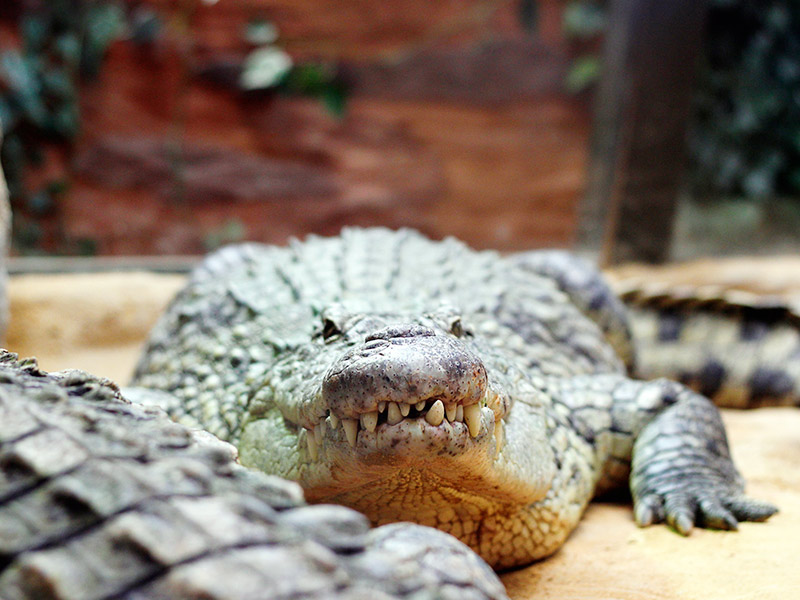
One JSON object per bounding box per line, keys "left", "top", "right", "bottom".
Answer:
{"left": 239, "top": 306, "right": 555, "bottom": 566}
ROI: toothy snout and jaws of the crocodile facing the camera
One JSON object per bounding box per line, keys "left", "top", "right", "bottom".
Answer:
{"left": 298, "top": 325, "right": 510, "bottom": 466}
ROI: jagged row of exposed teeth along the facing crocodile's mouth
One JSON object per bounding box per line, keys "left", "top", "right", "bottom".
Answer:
{"left": 298, "top": 389, "right": 509, "bottom": 461}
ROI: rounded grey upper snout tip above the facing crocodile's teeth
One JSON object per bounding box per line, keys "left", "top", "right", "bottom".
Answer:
{"left": 322, "top": 325, "right": 487, "bottom": 418}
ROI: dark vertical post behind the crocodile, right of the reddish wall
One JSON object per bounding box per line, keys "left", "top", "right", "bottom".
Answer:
{"left": 578, "top": 0, "right": 705, "bottom": 264}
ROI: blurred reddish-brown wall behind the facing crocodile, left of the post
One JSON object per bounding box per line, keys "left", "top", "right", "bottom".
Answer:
{"left": 3, "top": 0, "right": 588, "bottom": 254}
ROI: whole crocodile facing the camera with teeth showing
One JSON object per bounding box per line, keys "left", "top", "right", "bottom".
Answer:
{"left": 127, "top": 228, "right": 776, "bottom": 569}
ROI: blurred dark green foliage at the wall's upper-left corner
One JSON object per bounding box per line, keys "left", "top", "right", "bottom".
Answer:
{"left": 0, "top": 0, "right": 123, "bottom": 249}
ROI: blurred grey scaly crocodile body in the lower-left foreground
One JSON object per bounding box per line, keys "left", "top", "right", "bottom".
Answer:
{"left": 0, "top": 352, "right": 507, "bottom": 600}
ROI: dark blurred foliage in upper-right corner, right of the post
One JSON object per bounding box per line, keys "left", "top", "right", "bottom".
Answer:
{"left": 691, "top": 0, "right": 800, "bottom": 198}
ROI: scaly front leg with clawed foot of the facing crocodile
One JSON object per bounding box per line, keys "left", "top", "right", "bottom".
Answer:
{"left": 554, "top": 375, "right": 777, "bottom": 535}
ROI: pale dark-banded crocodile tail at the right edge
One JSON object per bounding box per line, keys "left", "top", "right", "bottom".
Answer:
{"left": 621, "top": 288, "right": 800, "bottom": 408}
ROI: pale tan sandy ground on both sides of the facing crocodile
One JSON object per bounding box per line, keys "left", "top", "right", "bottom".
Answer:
{"left": 7, "top": 273, "right": 800, "bottom": 600}
